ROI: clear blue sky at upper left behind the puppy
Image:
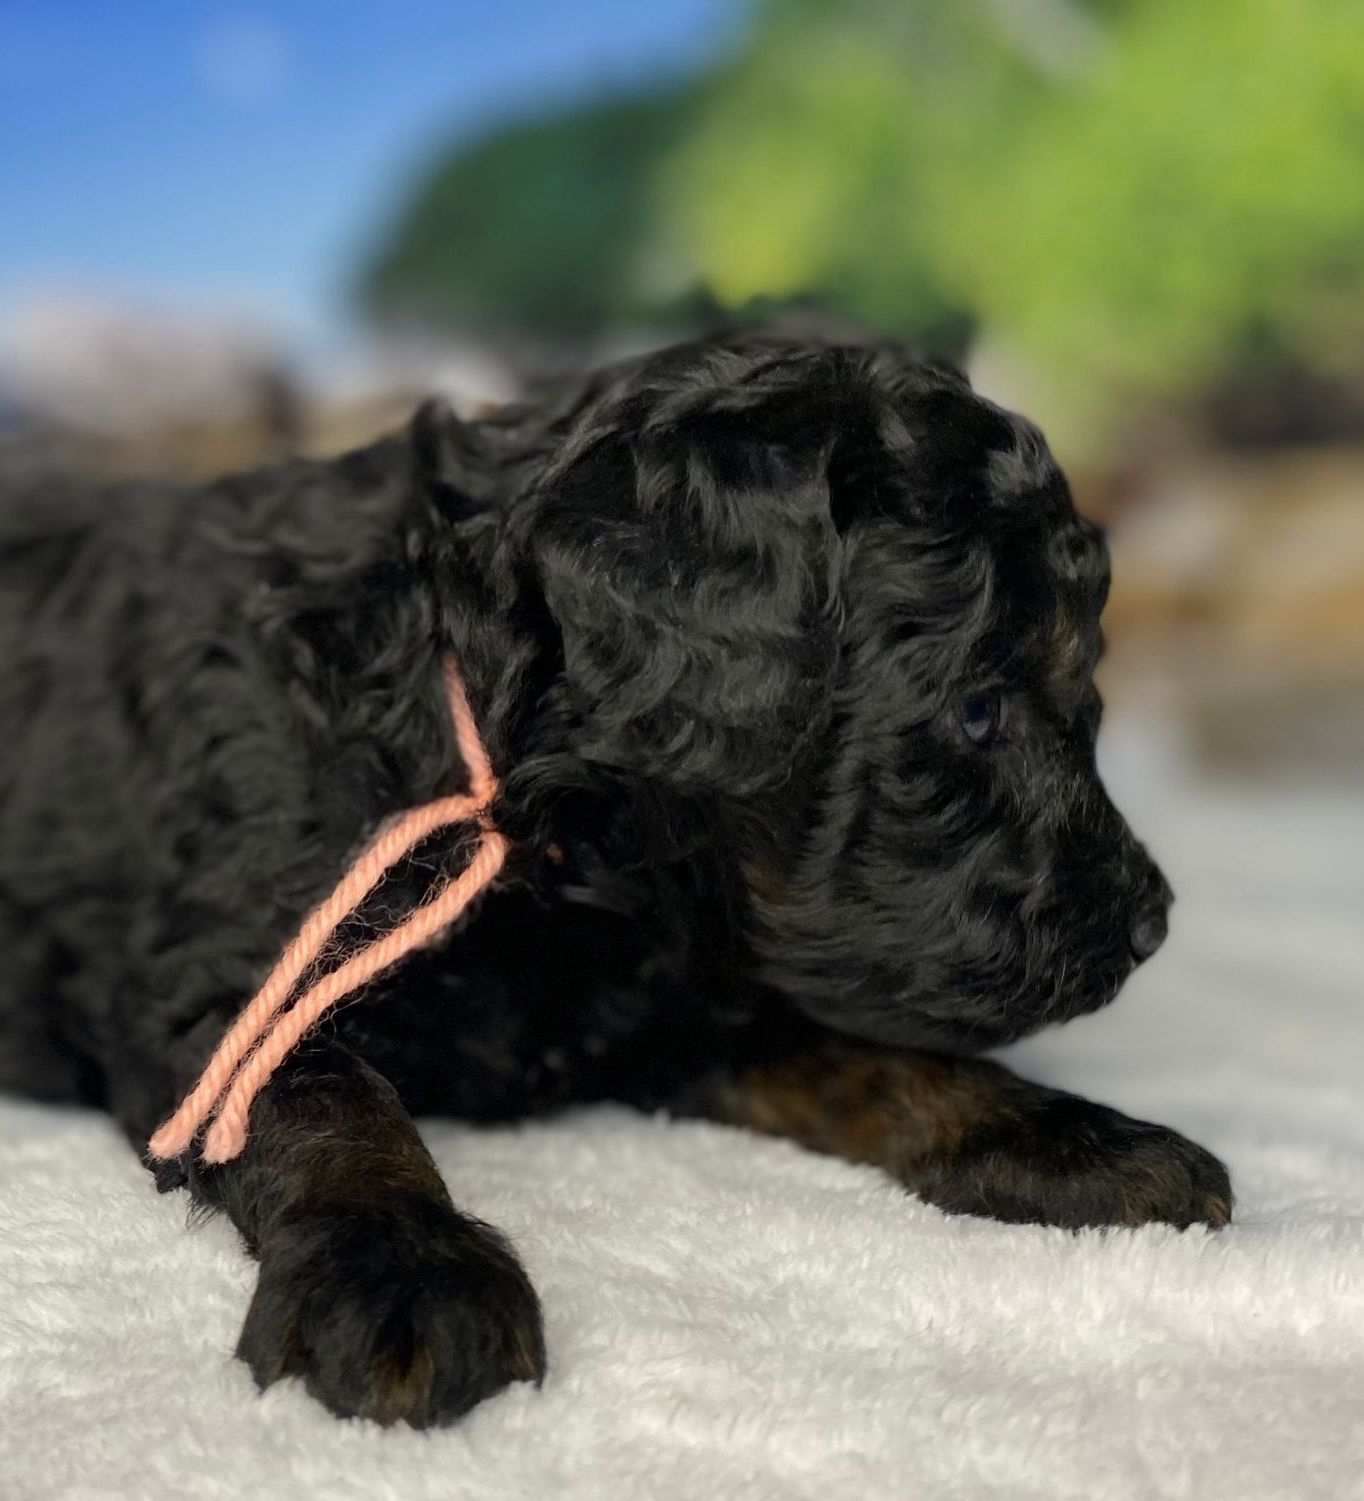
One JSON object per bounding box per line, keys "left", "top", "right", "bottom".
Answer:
{"left": 0, "top": 0, "right": 740, "bottom": 342}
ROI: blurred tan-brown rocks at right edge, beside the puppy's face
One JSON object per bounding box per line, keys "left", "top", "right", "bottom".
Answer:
{"left": 1104, "top": 447, "right": 1364, "bottom": 779}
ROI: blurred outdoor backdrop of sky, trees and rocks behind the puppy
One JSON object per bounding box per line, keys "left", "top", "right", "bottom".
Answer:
{"left": 0, "top": 0, "right": 1364, "bottom": 806}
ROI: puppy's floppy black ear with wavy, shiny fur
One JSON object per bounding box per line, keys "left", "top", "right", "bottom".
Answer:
{"left": 525, "top": 401, "right": 840, "bottom": 796}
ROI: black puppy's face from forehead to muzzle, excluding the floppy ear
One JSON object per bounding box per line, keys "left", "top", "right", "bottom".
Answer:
{"left": 744, "top": 355, "right": 1170, "bottom": 1049}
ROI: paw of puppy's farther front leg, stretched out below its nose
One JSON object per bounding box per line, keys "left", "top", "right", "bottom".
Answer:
{"left": 911, "top": 1094, "right": 1232, "bottom": 1229}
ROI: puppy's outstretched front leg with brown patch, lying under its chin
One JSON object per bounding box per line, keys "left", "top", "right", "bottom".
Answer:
{"left": 705, "top": 1045, "right": 1232, "bottom": 1229}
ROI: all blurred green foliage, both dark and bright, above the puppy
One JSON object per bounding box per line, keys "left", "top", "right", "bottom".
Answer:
{"left": 368, "top": 0, "right": 1364, "bottom": 438}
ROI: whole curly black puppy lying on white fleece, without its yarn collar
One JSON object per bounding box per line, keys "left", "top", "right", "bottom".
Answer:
{"left": 0, "top": 335, "right": 1230, "bottom": 1424}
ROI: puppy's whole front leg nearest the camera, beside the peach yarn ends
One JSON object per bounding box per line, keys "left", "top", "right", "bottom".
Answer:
{"left": 179, "top": 1040, "right": 545, "bottom": 1427}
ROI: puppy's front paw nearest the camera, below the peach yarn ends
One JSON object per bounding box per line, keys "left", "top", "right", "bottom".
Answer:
{"left": 237, "top": 1204, "right": 545, "bottom": 1427}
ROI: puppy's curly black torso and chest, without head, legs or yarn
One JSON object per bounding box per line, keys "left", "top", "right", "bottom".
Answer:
{"left": 0, "top": 414, "right": 792, "bottom": 1148}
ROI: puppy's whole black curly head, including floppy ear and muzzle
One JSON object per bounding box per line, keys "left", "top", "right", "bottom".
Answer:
{"left": 441, "top": 336, "right": 1169, "bottom": 1048}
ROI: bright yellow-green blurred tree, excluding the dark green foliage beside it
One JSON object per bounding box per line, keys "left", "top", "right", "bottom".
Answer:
{"left": 666, "top": 0, "right": 1364, "bottom": 438}
